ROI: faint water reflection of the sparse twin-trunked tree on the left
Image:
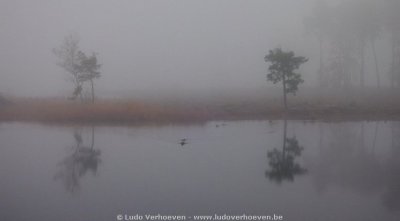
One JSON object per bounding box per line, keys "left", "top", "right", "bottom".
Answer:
{"left": 55, "top": 127, "right": 101, "bottom": 193}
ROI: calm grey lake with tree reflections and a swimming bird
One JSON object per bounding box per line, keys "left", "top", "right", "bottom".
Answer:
{"left": 0, "top": 120, "right": 400, "bottom": 221}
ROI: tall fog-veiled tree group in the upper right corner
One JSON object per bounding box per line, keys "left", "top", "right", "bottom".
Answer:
{"left": 304, "top": 0, "right": 400, "bottom": 88}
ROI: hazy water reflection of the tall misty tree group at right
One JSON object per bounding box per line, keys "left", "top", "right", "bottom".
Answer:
{"left": 309, "top": 122, "right": 400, "bottom": 211}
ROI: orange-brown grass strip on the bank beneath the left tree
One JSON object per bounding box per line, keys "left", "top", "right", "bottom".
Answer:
{"left": 0, "top": 99, "right": 212, "bottom": 123}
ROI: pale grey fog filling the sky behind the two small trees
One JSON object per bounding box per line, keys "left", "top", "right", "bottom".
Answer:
{"left": 0, "top": 0, "right": 398, "bottom": 97}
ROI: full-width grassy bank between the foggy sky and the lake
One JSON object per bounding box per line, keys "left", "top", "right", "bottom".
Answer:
{"left": 0, "top": 89, "right": 400, "bottom": 124}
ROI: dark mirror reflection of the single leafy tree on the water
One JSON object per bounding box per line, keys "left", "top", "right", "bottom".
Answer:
{"left": 265, "top": 119, "right": 307, "bottom": 183}
